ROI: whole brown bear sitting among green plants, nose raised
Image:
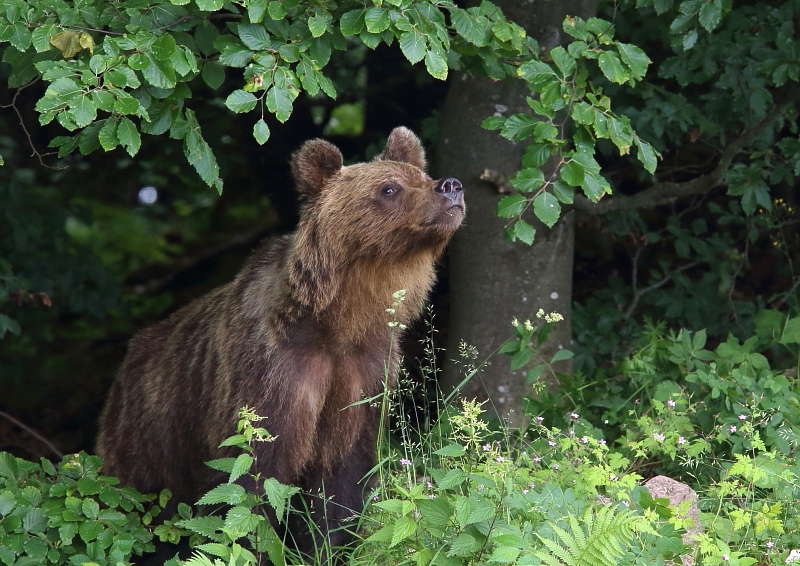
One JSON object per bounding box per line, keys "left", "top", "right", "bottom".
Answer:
{"left": 97, "top": 128, "right": 465, "bottom": 552}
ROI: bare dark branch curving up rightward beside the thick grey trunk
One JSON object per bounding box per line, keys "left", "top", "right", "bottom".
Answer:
{"left": 574, "top": 85, "right": 800, "bottom": 214}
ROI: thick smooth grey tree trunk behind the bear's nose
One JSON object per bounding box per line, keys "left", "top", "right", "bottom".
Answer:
{"left": 437, "top": 0, "right": 595, "bottom": 426}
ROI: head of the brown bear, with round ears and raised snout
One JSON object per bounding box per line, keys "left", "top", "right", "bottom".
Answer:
{"left": 291, "top": 127, "right": 465, "bottom": 322}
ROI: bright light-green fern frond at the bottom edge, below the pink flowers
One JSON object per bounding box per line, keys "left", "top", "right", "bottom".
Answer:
{"left": 536, "top": 505, "right": 654, "bottom": 566}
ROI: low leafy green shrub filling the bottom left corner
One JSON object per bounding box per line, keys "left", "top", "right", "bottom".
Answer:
{"left": 0, "top": 452, "right": 155, "bottom": 566}
